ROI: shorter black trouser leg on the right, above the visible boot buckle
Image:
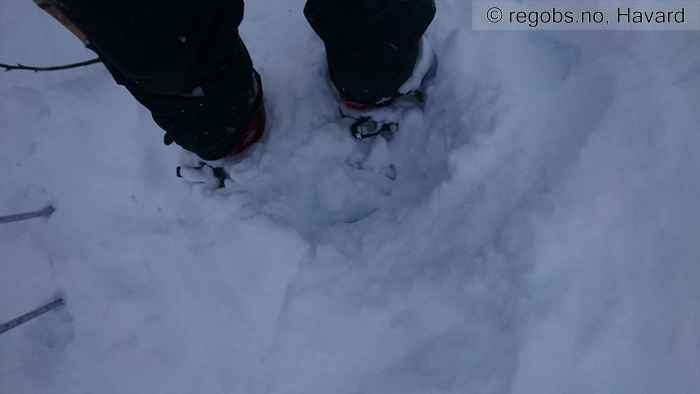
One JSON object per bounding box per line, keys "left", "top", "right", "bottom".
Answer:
{"left": 304, "top": 0, "right": 435, "bottom": 104}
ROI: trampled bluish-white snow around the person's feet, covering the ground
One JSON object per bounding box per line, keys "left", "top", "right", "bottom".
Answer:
{"left": 0, "top": 0, "right": 700, "bottom": 394}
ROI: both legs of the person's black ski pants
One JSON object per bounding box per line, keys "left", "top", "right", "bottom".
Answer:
{"left": 34, "top": 0, "right": 435, "bottom": 160}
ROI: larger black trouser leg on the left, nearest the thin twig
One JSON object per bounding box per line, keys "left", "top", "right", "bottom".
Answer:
{"left": 35, "top": 0, "right": 261, "bottom": 160}
